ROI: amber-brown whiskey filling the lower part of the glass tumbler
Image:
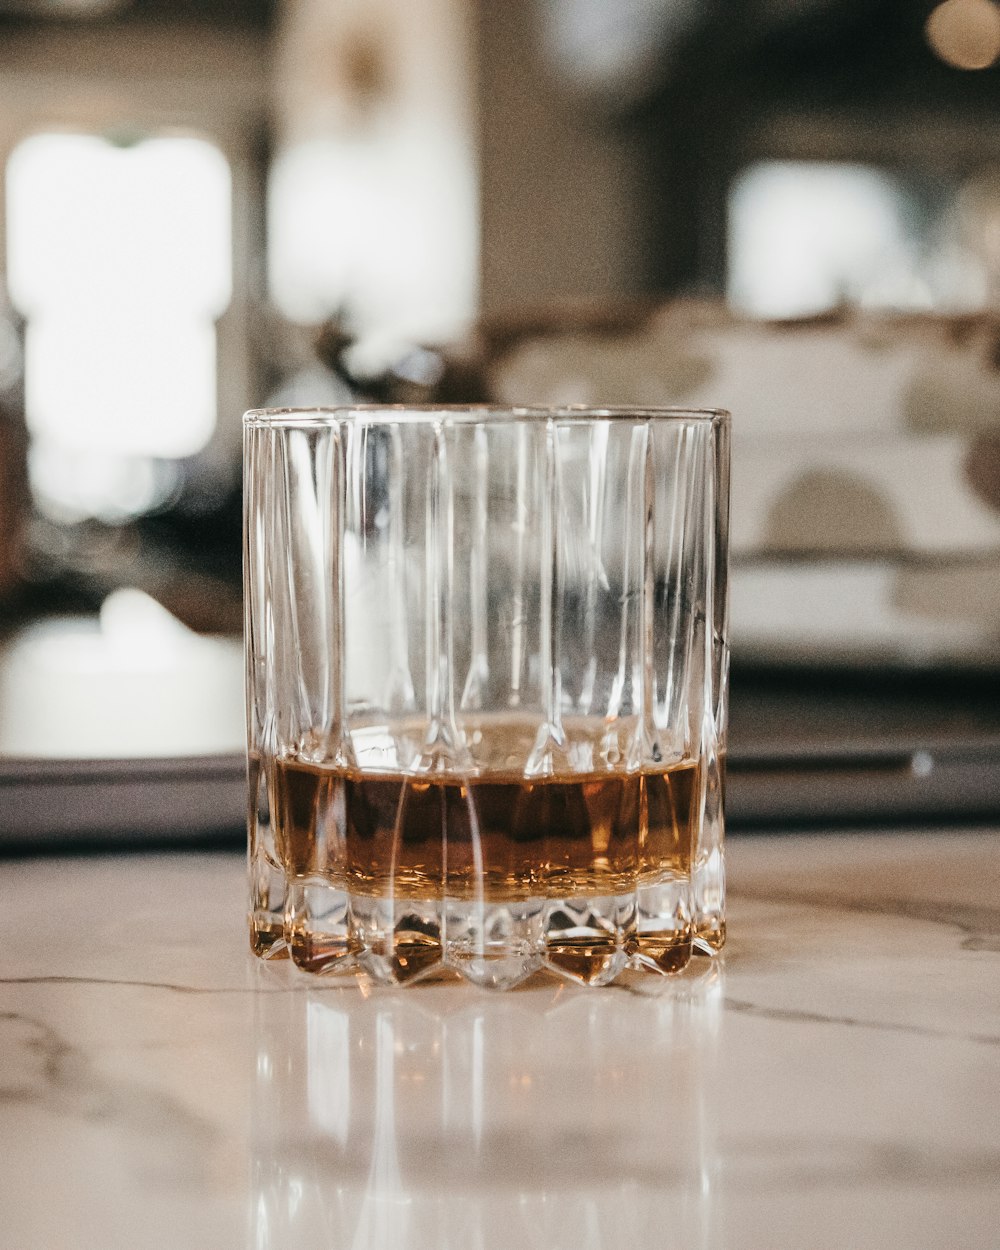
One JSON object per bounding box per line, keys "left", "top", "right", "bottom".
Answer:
{"left": 273, "top": 758, "right": 698, "bottom": 900}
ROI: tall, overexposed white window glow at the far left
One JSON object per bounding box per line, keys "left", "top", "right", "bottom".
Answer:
{"left": 6, "top": 134, "right": 231, "bottom": 515}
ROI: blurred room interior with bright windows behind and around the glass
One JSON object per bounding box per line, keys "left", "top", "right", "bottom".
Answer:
{"left": 0, "top": 0, "right": 1000, "bottom": 840}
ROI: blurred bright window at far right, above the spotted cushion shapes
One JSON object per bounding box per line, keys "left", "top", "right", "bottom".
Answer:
{"left": 728, "top": 161, "right": 1000, "bottom": 316}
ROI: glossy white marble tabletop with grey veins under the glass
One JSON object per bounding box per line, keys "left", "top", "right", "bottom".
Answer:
{"left": 0, "top": 830, "right": 1000, "bottom": 1250}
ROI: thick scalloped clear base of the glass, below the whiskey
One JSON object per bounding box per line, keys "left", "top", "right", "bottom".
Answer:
{"left": 250, "top": 863, "right": 725, "bottom": 990}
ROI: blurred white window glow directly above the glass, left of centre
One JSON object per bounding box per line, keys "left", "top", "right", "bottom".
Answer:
{"left": 268, "top": 126, "right": 478, "bottom": 340}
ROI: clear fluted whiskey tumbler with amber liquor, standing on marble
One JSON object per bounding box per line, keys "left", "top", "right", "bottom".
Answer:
{"left": 244, "top": 405, "right": 729, "bottom": 989}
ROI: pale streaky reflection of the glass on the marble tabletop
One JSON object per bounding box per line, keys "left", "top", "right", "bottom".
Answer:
{"left": 249, "top": 960, "right": 724, "bottom": 1250}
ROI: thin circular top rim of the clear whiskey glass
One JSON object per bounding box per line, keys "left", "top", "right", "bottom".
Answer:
{"left": 243, "top": 403, "right": 731, "bottom": 430}
